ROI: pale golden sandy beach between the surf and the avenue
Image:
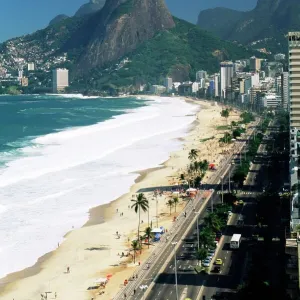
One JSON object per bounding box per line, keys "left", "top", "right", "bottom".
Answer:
{"left": 0, "top": 97, "right": 239, "bottom": 300}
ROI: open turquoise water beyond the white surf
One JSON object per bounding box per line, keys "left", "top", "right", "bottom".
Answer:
{"left": 0, "top": 95, "right": 146, "bottom": 166}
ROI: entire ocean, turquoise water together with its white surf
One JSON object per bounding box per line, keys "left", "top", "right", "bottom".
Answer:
{"left": 0, "top": 95, "right": 198, "bottom": 277}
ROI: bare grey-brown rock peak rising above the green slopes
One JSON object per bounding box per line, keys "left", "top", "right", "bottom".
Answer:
{"left": 79, "top": 0, "right": 175, "bottom": 71}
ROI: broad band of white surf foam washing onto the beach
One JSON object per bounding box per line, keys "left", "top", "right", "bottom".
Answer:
{"left": 0, "top": 98, "right": 197, "bottom": 276}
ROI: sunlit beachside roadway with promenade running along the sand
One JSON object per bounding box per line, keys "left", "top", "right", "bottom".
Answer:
{"left": 114, "top": 122, "right": 257, "bottom": 300}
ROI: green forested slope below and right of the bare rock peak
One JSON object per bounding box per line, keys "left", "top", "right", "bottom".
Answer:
{"left": 74, "top": 18, "right": 253, "bottom": 89}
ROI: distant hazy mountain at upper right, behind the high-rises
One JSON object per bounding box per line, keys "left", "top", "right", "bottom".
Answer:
{"left": 197, "top": 0, "right": 300, "bottom": 52}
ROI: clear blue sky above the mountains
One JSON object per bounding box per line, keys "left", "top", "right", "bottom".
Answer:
{"left": 0, "top": 0, "right": 257, "bottom": 41}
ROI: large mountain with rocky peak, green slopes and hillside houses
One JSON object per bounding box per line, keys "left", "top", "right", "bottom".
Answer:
{"left": 0, "top": 0, "right": 253, "bottom": 90}
